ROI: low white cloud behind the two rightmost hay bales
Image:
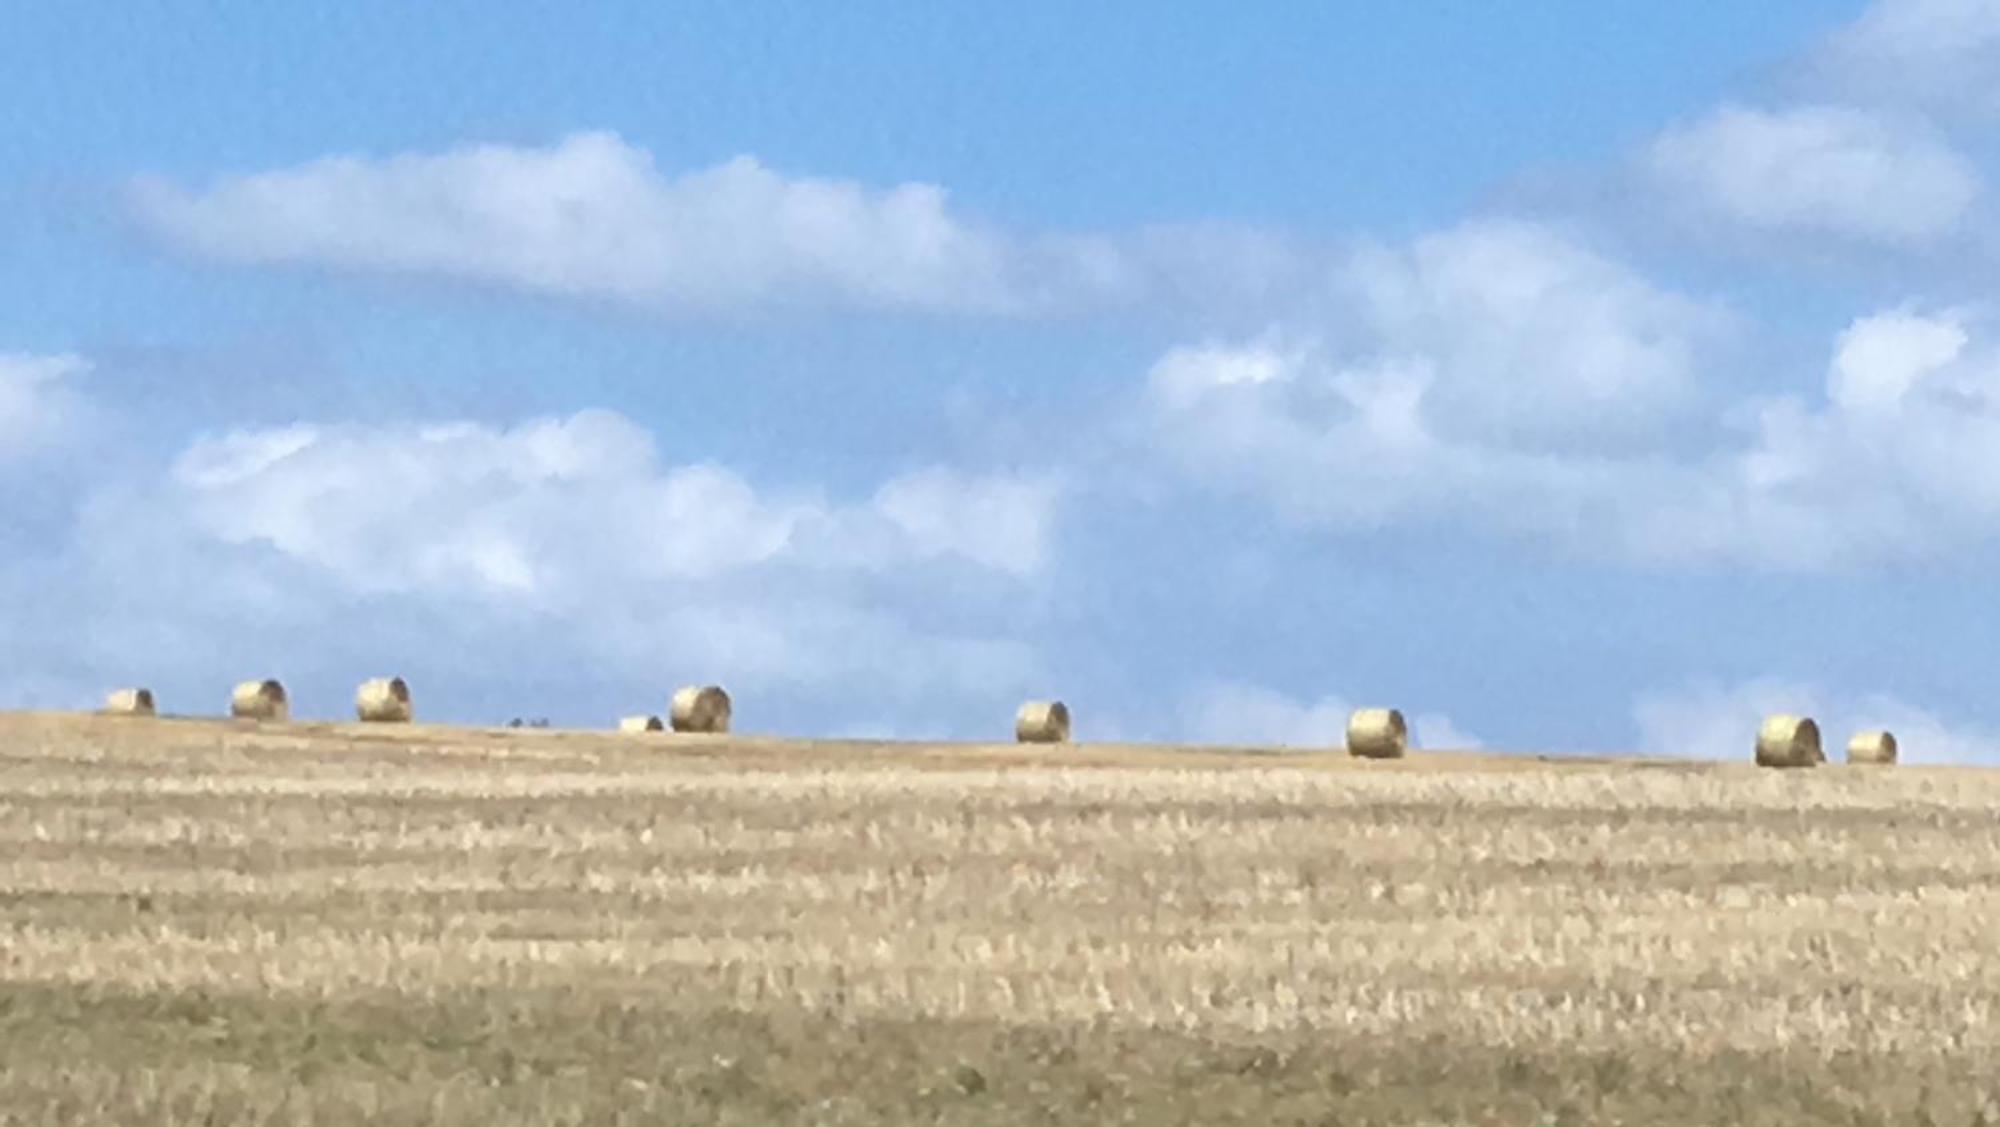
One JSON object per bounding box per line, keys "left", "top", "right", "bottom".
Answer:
{"left": 1632, "top": 677, "right": 2000, "bottom": 763}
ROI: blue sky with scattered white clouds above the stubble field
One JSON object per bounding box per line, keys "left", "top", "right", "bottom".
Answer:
{"left": 0, "top": 0, "right": 2000, "bottom": 761}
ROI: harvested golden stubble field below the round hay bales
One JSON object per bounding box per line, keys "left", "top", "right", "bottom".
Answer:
{"left": 0, "top": 715, "right": 2000, "bottom": 1127}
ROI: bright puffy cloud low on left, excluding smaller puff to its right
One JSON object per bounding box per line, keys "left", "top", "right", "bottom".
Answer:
{"left": 160, "top": 412, "right": 804, "bottom": 597}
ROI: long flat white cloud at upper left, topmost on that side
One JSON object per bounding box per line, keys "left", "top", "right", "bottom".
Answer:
{"left": 130, "top": 132, "right": 1130, "bottom": 314}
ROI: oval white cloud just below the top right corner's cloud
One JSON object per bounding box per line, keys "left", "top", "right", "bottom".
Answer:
{"left": 1646, "top": 106, "right": 1980, "bottom": 246}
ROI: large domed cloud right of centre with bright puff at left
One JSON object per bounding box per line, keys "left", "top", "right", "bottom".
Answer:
{"left": 1146, "top": 222, "right": 1730, "bottom": 540}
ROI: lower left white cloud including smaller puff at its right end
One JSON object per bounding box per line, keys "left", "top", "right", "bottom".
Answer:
{"left": 158, "top": 412, "right": 1054, "bottom": 603}
